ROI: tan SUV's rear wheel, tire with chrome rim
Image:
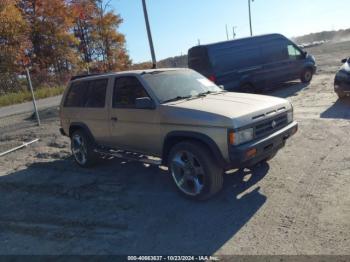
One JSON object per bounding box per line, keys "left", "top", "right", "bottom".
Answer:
{"left": 71, "top": 130, "right": 98, "bottom": 168}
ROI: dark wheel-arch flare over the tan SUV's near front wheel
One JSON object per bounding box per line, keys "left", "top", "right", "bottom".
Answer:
{"left": 162, "top": 131, "right": 228, "bottom": 166}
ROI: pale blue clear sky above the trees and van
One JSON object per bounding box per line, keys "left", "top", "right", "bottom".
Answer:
{"left": 111, "top": 0, "right": 350, "bottom": 63}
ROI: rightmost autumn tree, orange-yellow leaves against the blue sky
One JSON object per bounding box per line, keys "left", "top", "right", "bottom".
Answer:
{"left": 70, "top": 0, "right": 131, "bottom": 72}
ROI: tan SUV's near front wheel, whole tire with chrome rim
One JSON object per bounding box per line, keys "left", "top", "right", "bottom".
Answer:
{"left": 168, "top": 141, "right": 224, "bottom": 200}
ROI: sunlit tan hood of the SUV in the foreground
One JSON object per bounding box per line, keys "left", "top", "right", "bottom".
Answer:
{"left": 162, "top": 92, "right": 292, "bottom": 128}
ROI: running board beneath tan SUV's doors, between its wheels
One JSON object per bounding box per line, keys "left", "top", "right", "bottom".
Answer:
{"left": 94, "top": 148, "right": 162, "bottom": 166}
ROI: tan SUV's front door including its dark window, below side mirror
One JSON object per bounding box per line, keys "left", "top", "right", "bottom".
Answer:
{"left": 110, "top": 76, "right": 161, "bottom": 155}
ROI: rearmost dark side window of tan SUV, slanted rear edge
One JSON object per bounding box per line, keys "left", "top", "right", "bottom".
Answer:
{"left": 64, "top": 81, "right": 89, "bottom": 107}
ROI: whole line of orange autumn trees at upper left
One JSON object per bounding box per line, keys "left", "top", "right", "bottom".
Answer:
{"left": 0, "top": 0, "right": 131, "bottom": 91}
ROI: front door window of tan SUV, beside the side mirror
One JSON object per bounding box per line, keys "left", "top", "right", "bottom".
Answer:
{"left": 113, "top": 77, "right": 149, "bottom": 108}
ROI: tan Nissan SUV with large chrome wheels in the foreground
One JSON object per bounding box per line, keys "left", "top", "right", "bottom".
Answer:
{"left": 60, "top": 69, "right": 298, "bottom": 200}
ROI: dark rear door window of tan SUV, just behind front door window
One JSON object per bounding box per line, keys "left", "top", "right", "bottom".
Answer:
{"left": 85, "top": 79, "right": 108, "bottom": 108}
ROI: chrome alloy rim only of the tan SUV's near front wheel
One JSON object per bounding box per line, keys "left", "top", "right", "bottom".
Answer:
{"left": 171, "top": 151, "right": 204, "bottom": 196}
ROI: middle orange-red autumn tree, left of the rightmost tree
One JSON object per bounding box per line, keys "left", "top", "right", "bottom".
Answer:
{"left": 19, "top": 0, "right": 77, "bottom": 77}
